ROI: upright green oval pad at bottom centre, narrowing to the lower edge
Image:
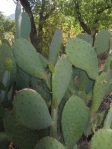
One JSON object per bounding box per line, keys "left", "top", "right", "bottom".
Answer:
{"left": 62, "top": 96, "right": 89, "bottom": 148}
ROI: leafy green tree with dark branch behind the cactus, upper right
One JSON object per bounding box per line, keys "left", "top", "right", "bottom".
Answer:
{"left": 59, "top": 0, "right": 112, "bottom": 34}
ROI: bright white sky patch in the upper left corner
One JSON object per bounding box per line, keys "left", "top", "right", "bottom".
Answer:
{"left": 0, "top": 0, "right": 16, "bottom": 16}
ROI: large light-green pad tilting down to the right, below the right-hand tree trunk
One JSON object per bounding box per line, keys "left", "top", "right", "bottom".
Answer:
{"left": 66, "top": 38, "right": 98, "bottom": 80}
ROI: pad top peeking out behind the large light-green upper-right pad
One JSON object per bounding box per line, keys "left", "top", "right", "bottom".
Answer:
{"left": 77, "top": 34, "right": 93, "bottom": 45}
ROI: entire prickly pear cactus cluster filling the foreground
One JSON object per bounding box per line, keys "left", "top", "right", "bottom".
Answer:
{"left": 0, "top": 3, "right": 112, "bottom": 149}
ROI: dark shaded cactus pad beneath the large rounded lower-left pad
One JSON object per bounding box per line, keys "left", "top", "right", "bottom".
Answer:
{"left": 4, "top": 112, "right": 38, "bottom": 149}
